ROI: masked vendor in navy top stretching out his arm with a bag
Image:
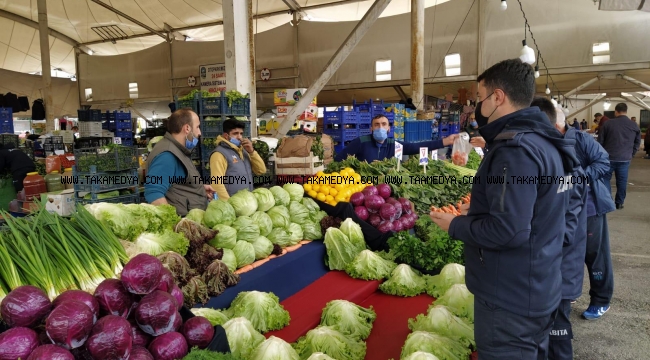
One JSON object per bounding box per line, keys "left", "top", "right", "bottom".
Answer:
{"left": 335, "top": 115, "right": 458, "bottom": 163}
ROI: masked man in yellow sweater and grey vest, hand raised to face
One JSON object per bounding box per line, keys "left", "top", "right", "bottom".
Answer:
{"left": 210, "top": 119, "right": 266, "bottom": 200}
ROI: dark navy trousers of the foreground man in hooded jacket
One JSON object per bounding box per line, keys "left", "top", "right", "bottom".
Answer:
{"left": 474, "top": 297, "right": 557, "bottom": 360}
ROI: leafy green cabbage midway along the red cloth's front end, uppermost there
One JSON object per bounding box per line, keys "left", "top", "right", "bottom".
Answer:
{"left": 320, "top": 300, "right": 377, "bottom": 340}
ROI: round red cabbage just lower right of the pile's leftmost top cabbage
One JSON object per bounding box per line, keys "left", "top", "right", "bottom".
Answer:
{"left": 45, "top": 300, "right": 94, "bottom": 349}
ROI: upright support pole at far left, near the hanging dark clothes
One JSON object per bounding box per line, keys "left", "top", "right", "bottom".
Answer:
{"left": 37, "top": 0, "right": 54, "bottom": 132}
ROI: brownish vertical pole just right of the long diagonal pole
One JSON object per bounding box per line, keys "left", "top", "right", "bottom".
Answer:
{"left": 411, "top": 0, "right": 422, "bottom": 110}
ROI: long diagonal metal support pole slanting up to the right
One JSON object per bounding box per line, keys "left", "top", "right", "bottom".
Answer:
{"left": 273, "top": 0, "right": 391, "bottom": 139}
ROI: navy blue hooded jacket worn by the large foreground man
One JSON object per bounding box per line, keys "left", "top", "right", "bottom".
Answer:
{"left": 449, "top": 107, "right": 578, "bottom": 317}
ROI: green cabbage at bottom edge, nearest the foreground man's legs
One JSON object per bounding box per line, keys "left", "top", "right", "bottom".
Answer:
{"left": 401, "top": 331, "right": 472, "bottom": 359}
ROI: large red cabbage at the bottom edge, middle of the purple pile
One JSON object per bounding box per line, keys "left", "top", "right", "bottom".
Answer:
{"left": 87, "top": 315, "right": 133, "bottom": 360}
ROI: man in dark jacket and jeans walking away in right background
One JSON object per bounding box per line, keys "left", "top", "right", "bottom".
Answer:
{"left": 598, "top": 103, "right": 641, "bottom": 209}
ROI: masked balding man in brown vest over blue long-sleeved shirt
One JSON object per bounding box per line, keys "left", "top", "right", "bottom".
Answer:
{"left": 144, "top": 109, "right": 214, "bottom": 216}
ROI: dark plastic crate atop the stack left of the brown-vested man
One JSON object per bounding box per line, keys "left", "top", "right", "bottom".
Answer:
{"left": 74, "top": 146, "right": 139, "bottom": 172}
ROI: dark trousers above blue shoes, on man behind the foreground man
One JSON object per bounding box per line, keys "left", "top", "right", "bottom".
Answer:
{"left": 585, "top": 214, "right": 614, "bottom": 306}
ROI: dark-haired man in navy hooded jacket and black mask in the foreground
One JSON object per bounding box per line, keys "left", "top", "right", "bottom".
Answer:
{"left": 430, "top": 59, "right": 578, "bottom": 360}
